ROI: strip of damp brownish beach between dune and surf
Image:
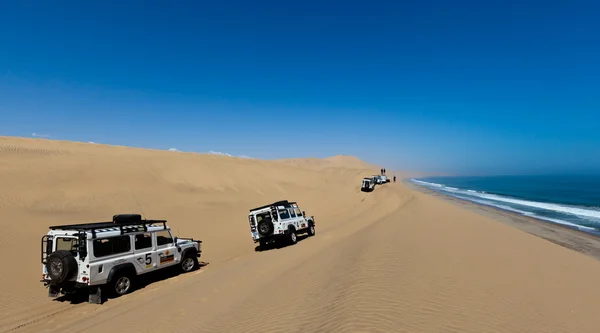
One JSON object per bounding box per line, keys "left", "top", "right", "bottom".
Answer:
{"left": 401, "top": 179, "right": 600, "bottom": 261}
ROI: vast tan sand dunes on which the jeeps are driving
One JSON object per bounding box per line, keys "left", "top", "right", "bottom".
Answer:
{"left": 0, "top": 138, "right": 600, "bottom": 333}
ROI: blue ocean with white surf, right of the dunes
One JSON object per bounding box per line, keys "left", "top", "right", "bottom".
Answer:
{"left": 410, "top": 175, "right": 600, "bottom": 236}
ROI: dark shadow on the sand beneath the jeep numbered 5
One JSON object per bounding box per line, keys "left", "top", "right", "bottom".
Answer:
{"left": 53, "top": 261, "right": 209, "bottom": 304}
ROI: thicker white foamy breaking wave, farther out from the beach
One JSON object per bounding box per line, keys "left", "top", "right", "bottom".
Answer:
{"left": 413, "top": 180, "right": 600, "bottom": 223}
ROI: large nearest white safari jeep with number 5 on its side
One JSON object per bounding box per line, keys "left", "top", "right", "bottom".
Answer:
{"left": 40, "top": 214, "right": 202, "bottom": 304}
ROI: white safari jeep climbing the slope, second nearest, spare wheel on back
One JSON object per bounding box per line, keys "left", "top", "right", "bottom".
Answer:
{"left": 248, "top": 200, "right": 315, "bottom": 249}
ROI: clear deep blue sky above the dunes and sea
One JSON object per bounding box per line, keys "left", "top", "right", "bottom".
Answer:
{"left": 0, "top": 0, "right": 600, "bottom": 174}
